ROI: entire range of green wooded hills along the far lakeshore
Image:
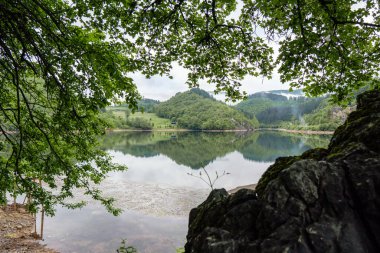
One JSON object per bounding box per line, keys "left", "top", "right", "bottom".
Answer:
{"left": 101, "top": 88, "right": 355, "bottom": 131}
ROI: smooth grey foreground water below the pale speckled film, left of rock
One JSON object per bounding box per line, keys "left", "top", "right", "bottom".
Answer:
{"left": 45, "top": 205, "right": 187, "bottom": 253}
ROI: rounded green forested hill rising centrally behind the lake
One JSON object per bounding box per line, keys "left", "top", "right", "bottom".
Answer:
{"left": 155, "top": 89, "right": 258, "bottom": 130}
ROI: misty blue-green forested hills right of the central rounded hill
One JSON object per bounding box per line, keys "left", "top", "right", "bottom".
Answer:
{"left": 235, "top": 90, "right": 352, "bottom": 130}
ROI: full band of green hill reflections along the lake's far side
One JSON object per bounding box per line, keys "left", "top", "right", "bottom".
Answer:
{"left": 100, "top": 132, "right": 329, "bottom": 169}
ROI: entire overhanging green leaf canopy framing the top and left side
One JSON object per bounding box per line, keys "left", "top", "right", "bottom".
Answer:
{"left": 0, "top": 0, "right": 380, "bottom": 213}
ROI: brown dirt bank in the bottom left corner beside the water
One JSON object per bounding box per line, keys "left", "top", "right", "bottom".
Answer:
{"left": 0, "top": 204, "right": 58, "bottom": 253}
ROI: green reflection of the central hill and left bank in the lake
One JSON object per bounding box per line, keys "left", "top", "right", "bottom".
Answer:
{"left": 100, "top": 132, "right": 244, "bottom": 169}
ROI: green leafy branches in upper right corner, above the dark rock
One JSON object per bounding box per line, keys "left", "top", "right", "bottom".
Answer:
{"left": 242, "top": 0, "right": 380, "bottom": 101}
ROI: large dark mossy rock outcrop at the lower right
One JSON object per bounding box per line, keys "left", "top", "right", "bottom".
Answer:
{"left": 185, "top": 90, "right": 380, "bottom": 253}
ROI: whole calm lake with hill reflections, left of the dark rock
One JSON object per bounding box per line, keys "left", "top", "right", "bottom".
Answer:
{"left": 38, "top": 131, "right": 331, "bottom": 253}
